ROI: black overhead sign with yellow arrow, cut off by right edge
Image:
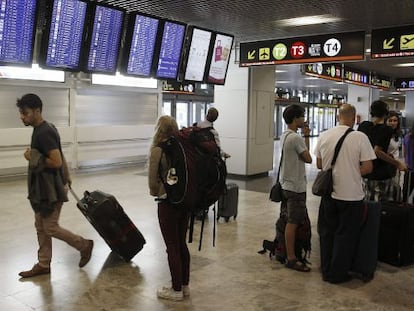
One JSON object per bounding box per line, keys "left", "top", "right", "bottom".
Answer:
{"left": 371, "top": 25, "right": 414, "bottom": 58}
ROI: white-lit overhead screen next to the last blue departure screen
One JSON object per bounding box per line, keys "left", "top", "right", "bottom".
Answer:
{"left": 184, "top": 27, "right": 212, "bottom": 82}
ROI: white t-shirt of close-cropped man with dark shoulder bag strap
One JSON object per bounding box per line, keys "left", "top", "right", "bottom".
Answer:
{"left": 314, "top": 125, "right": 376, "bottom": 201}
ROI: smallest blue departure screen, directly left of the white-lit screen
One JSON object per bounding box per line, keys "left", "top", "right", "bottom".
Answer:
{"left": 156, "top": 22, "right": 185, "bottom": 79}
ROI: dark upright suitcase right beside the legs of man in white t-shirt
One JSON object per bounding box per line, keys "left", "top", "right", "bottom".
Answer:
{"left": 351, "top": 201, "right": 381, "bottom": 282}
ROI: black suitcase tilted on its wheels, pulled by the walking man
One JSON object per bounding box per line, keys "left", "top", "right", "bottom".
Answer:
{"left": 70, "top": 189, "right": 146, "bottom": 261}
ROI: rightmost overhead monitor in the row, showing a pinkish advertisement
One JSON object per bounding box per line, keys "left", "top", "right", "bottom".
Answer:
{"left": 205, "top": 33, "right": 234, "bottom": 85}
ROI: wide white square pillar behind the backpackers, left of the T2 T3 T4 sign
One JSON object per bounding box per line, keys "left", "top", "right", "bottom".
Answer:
{"left": 214, "top": 50, "right": 275, "bottom": 176}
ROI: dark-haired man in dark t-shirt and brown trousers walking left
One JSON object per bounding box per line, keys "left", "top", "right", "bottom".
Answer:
{"left": 16, "top": 94, "right": 93, "bottom": 278}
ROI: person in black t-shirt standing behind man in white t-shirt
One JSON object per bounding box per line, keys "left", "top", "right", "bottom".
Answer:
{"left": 358, "top": 100, "right": 407, "bottom": 201}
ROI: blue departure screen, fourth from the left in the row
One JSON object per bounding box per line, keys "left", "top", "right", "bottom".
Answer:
{"left": 127, "top": 15, "right": 159, "bottom": 76}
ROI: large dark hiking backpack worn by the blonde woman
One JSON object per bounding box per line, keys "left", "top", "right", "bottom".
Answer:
{"left": 159, "top": 127, "right": 227, "bottom": 247}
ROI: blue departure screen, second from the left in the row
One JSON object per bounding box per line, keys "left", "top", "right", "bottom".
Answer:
{"left": 46, "top": 0, "right": 87, "bottom": 69}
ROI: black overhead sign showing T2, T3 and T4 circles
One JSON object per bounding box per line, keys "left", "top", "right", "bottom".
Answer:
{"left": 239, "top": 31, "right": 365, "bottom": 67}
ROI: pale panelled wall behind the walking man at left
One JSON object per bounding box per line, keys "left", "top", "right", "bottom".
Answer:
{"left": 0, "top": 75, "right": 162, "bottom": 176}
